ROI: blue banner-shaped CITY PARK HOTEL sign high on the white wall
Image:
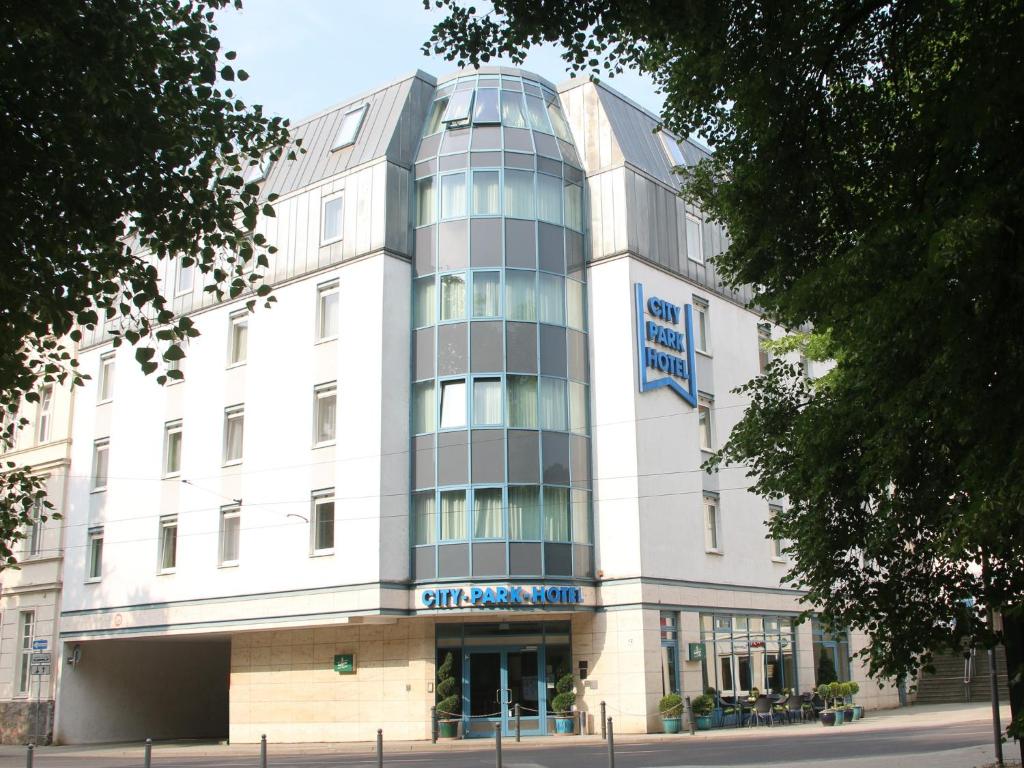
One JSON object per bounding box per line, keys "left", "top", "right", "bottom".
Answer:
{"left": 633, "top": 283, "right": 697, "bottom": 408}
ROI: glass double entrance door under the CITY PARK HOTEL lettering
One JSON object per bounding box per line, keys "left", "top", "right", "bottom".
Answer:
{"left": 463, "top": 647, "right": 546, "bottom": 737}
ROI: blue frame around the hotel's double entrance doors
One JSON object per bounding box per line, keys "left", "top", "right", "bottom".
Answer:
{"left": 462, "top": 644, "right": 548, "bottom": 738}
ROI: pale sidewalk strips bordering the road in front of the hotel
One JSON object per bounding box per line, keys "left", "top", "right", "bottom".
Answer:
{"left": 0, "top": 703, "right": 1019, "bottom": 768}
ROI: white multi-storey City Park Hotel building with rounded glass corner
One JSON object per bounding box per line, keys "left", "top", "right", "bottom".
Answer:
{"left": 56, "top": 69, "right": 896, "bottom": 741}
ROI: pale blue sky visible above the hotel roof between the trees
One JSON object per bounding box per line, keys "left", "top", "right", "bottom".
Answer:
{"left": 216, "top": 0, "right": 663, "bottom": 123}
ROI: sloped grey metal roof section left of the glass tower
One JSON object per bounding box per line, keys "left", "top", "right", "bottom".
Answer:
{"left": 254, "top": 70, "right": 436, "bottom": 197}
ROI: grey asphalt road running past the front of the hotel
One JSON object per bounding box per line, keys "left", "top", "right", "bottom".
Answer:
{"left": 0, "top": 721, "right": 992, "bottom": 768}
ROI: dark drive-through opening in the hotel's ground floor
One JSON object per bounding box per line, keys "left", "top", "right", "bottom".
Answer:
{"left": 54, "top": 640, "right": 230, "bottom": 743}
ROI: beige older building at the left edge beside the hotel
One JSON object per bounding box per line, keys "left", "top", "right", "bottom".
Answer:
{"left": 0, "top": 372, "right": 74, "bottom": 744}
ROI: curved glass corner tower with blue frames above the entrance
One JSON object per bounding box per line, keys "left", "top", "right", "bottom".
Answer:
{"left": 410, "top": 71, "right": 593, "bottom": 581}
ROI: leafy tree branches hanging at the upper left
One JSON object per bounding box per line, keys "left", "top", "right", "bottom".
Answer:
{"left": 0, "top": 0, "right": 299, "bottom": 567}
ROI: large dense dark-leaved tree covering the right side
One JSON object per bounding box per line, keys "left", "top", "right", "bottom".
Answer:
{"left": 427, "top": 0, "right": 1024, "bottom": 745}
